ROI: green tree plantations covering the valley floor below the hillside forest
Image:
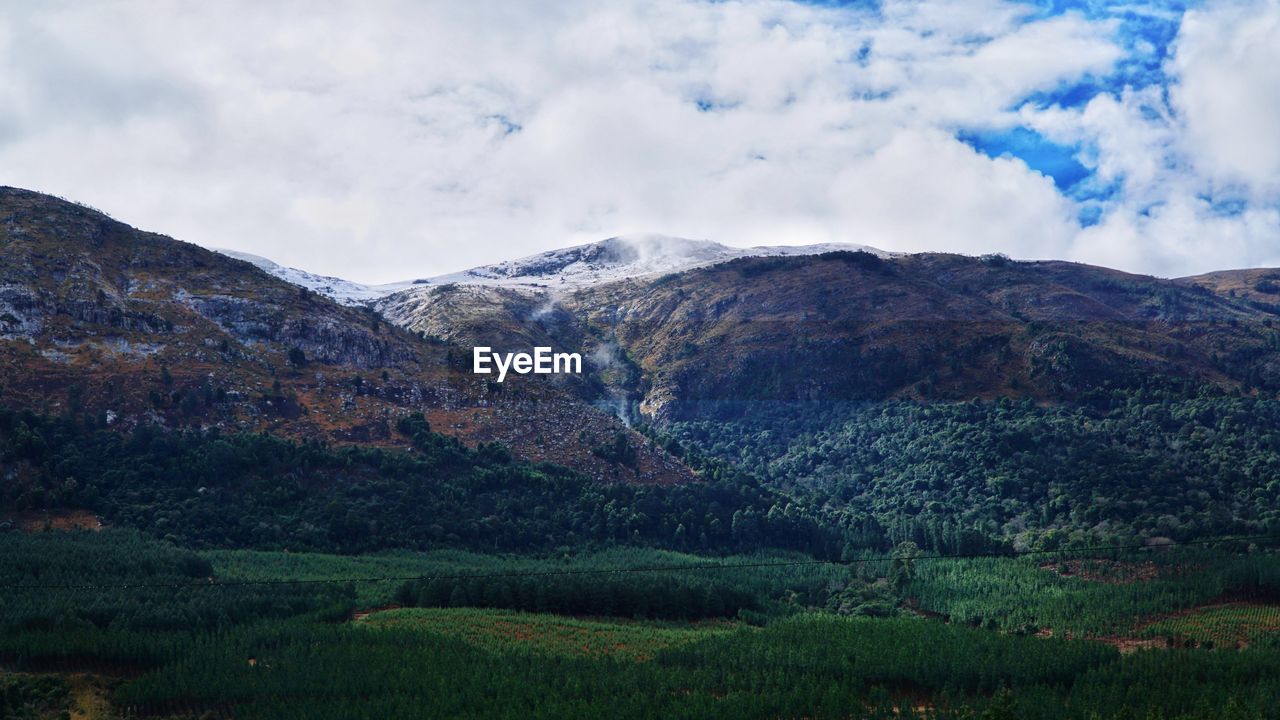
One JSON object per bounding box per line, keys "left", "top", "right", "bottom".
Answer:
{"left": 0, "top": 529, "right": 1280, "bottom": 720}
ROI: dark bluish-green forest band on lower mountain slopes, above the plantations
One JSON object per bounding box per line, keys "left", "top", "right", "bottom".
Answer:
{"left": 10, "top": 391, "right": 1280, "bottom": 559}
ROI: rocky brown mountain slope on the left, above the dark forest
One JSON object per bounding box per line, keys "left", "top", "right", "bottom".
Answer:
{"left": 0, "top": 187, "right": 691, "bottom": 483}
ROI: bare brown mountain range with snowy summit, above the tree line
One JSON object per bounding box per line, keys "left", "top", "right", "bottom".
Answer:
{"left": 10, "top": 188, "right": 1280, "bottom": 440}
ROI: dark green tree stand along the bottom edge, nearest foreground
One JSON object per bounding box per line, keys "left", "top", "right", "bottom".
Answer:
{"left": 107, "top": 615, "right": 1280, "bottom": 720}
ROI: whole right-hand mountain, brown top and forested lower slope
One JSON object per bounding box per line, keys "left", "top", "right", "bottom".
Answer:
{"left": 379, "top": 245, "right": 1280, "bottom": 543}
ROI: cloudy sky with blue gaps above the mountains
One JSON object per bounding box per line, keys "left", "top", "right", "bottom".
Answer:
{"left": 0, "top": 0, "right": 1280, "bottom": 282}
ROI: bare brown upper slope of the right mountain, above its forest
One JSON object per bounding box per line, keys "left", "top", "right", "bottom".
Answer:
{"left": 376, "top": 251, "right": 1280, "bottom": 419}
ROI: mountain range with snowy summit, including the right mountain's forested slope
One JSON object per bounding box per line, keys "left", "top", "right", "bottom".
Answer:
{"left": 0, "top": 183, "right": 1280, "bottom": 547}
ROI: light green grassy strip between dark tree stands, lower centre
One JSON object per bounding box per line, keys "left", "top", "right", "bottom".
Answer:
{"left": 362, "top": 607, "right": 750, "bottom": 661}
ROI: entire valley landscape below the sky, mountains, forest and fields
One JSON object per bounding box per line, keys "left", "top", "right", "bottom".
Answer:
{"left": 0, "top": 188, "right": 1280, "bottom": 720}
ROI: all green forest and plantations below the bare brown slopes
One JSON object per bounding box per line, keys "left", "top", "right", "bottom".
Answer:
{"left": 0, "top": 393, "right": 1280, "bottom": 720}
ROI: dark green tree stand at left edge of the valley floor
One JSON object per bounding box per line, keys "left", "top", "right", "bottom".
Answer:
{"left": 0, "top": 529, "right": 353, "bottom": 667}
